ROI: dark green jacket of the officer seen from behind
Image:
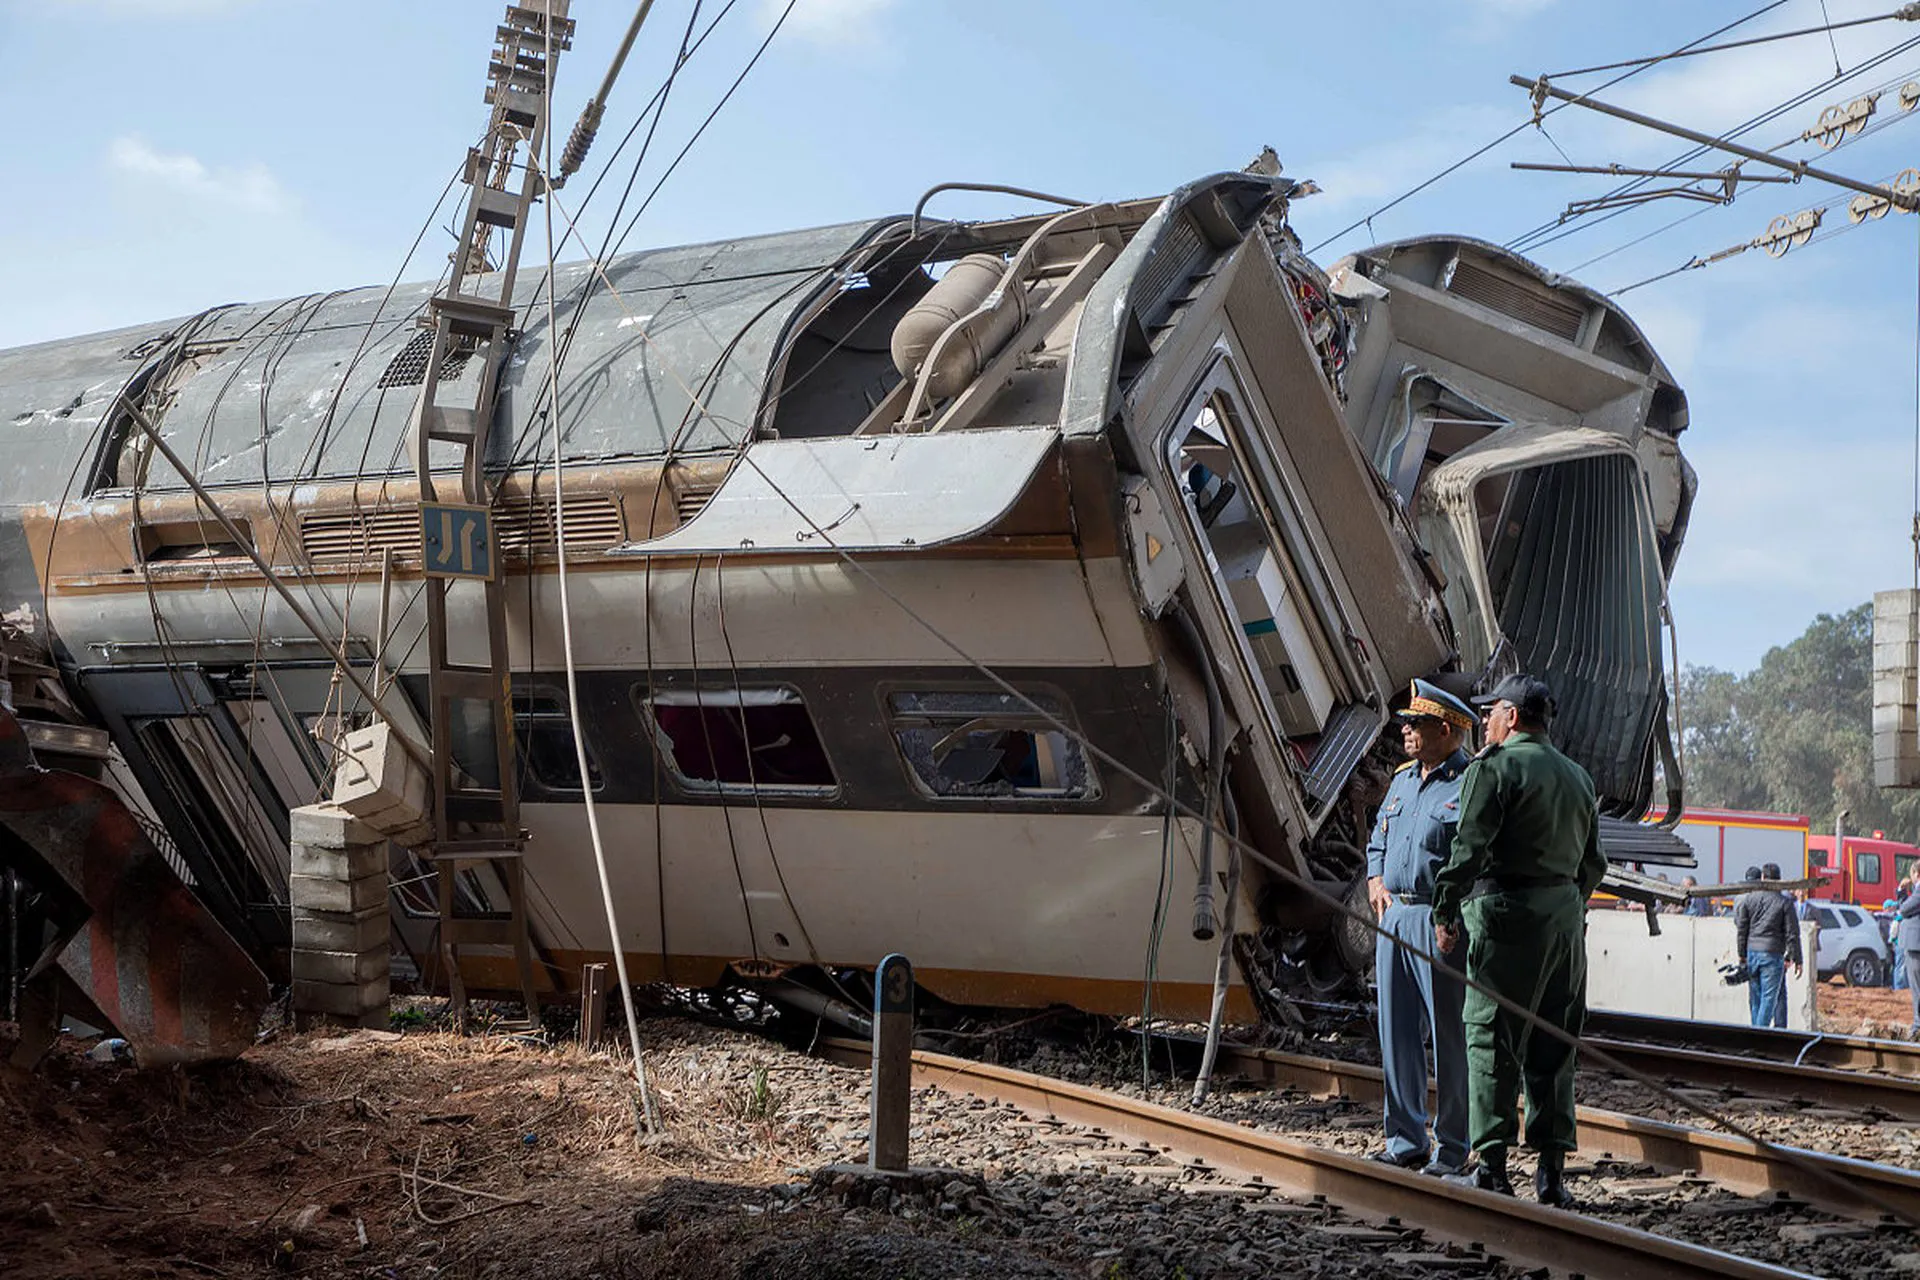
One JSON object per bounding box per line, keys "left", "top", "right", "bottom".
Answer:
{"left": 1434, "top": 733, "right": 1607, "bottom": 923}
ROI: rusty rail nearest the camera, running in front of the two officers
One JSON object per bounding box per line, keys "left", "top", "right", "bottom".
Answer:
{"left": 816, "top": 1040, "right": 1805, "bottom": 1280}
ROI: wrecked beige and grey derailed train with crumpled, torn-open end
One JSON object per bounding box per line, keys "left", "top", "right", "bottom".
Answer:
{"left": 0, "top": 175, "right": 1692, "bottom": 1051}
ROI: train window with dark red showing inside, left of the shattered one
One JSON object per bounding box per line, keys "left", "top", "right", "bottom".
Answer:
{"left": 636, "top": 687, "right": 839, "bottom": 793}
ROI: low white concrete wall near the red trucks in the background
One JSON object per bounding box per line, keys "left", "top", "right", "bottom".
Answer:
{"left": 1586, "top": 912, "right": 1814, "bottom": 1031}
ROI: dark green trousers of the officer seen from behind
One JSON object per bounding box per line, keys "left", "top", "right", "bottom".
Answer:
{"left": 1461, "top": 885, "right": 1586, "bottom": 1151}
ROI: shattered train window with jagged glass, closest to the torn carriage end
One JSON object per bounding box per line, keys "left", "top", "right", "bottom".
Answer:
{"left": 887, "top": 693, "right": 1098, "bottom": 800}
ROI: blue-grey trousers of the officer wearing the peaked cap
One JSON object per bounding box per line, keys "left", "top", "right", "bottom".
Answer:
{"left": 1373, "top": 902, "right": 1467, "bottom": 1169}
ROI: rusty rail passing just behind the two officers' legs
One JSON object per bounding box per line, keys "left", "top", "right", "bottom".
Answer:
{"left": 1213, "top": 1040, "right": 1920, "bottom": 1219}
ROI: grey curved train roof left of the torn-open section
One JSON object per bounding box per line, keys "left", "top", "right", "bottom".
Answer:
{"left": 0, "top": 217, "right": 904, "bottom": 505}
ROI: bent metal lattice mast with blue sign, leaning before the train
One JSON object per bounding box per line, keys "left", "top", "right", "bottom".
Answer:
{"left": 413, "top": 0, "right": 574, "bottom": 1027}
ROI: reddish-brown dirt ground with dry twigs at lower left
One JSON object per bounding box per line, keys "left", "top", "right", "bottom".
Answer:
{"left": 0, "top": 1019, "right": 1085, "bottom": 1280}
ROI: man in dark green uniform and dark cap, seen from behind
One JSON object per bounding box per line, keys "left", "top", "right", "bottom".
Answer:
{"left": 1434, "top": 676, "right": 1607, "bottom": 1207}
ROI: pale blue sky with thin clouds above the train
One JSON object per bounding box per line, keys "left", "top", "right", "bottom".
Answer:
{"left": 0, "top": 0, "right": 1920, "bottom": 670}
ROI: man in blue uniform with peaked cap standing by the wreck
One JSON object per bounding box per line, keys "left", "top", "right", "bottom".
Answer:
{"left": 1367, "top": 679, "right": 1475, "bottom": 1174}
